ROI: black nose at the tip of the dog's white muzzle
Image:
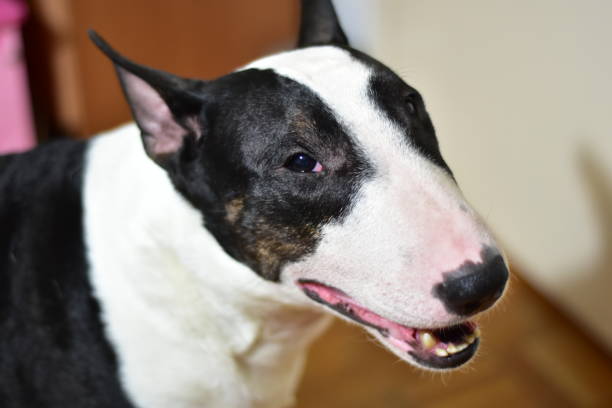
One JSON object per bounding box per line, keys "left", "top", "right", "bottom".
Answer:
{"left": 433, "top": 247, "right": 508, "bottom": 316}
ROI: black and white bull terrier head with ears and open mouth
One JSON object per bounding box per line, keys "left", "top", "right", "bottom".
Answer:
{"left": 92, "top": 0, "right": 508, "bottom": 369}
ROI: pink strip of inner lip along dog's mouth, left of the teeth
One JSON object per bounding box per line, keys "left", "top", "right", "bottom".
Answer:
{"left": 299, "top": 282, "right": 416, "bottom": 342}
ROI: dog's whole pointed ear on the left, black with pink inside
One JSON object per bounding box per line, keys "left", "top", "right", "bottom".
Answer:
{"left": 89, "top": 30, "right": 203, "bottom": 167}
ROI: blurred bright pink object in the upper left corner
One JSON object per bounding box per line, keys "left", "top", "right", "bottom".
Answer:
{"left": 0, "top": 0, "right": 34, "bottom": 154}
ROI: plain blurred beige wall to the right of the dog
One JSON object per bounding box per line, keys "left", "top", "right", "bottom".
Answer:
{"left": 336, "top": 0, "right": 612, "bottom": 350}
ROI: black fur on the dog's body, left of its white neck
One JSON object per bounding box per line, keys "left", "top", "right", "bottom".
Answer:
{"left": 0, "top": 142, "right": 132, "bottom": 408}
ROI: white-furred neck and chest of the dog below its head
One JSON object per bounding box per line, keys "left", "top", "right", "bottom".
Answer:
{"left": 84, "top": 125, "right": 327, "bottom": 407}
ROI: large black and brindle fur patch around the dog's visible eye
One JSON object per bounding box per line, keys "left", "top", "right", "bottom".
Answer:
{"left": 169, "top": 69, "right": 369, "bottom": 281}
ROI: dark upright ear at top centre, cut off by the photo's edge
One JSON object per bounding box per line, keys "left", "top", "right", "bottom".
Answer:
{"left": 298, "top": 0, "right": 348, "bottom": 47}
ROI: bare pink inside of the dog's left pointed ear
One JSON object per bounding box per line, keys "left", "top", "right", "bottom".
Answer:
{"left": 118, "top": 68, "right": 195, "bottom": 156}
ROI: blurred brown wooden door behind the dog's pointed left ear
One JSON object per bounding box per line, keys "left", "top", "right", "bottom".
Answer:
{"left": 24, "top": 0, "right": 299, "bottom": 138}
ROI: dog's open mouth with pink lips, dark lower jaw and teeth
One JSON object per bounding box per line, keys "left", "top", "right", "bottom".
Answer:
{"left": 298, "top": 280, "right": 480, "bottom": 370}
